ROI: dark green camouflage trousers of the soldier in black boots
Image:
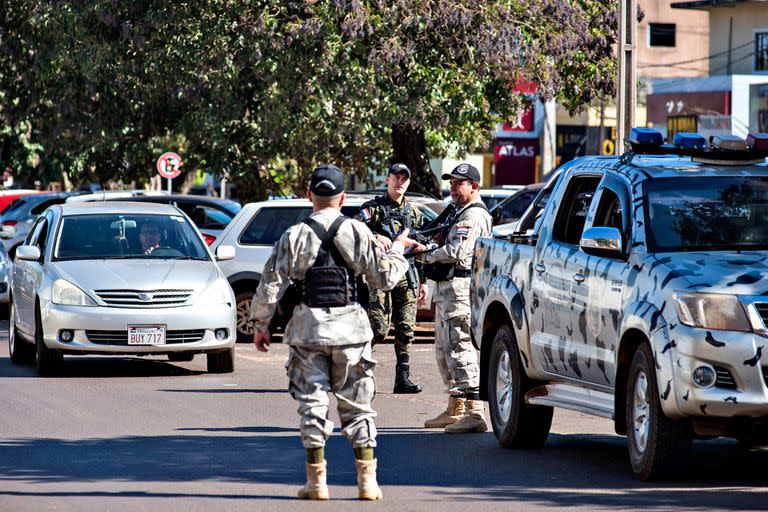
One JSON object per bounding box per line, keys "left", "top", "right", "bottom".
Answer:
{"left": 368, "top": 279, "right": 418, "bottom": 355}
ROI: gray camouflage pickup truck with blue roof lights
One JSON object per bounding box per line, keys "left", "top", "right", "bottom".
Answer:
{"left": 471, "top": 129, "right": 768, "bottom": 480}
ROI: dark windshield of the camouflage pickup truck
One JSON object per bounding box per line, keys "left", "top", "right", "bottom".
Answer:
{"left": 645, "top": 177, "right": 768, "bottom": 252}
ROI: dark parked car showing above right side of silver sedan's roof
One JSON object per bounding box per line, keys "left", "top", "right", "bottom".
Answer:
{"left": 103, "top": 194, "right": 241, "bottom": 245}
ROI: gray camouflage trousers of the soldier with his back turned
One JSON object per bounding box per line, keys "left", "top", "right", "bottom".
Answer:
{"left": 286, "top": 343, "right": 376, "bottom": 448}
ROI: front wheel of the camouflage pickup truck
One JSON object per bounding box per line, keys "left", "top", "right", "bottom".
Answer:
{"left": 626, "top": 343, "right": 693, "bottom": 480}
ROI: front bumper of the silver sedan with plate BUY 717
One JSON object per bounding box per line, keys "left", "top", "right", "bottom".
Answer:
{"left": 41, "top": 302, "right": 237, "bottom": 355}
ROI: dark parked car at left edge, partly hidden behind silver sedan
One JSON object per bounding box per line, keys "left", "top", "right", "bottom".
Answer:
{"left": 0, "top": 192, "right": 79, "bottom": 259}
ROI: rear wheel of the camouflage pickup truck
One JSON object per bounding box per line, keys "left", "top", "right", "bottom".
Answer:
{"left": 488, "top": 325, "right": 552, "bottom": 448}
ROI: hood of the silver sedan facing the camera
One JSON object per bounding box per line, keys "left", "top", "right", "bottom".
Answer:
{"left": 53, "top": 260, "right": 219, "bottom": 293}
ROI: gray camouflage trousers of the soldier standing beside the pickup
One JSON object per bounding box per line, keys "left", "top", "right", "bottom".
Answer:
{"left": 434, "top": 278, "right": 480, "bottom": 396}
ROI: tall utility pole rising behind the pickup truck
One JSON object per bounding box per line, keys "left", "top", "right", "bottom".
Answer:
{"left": 616, "top": 0, "right": 637, "bottom": 155}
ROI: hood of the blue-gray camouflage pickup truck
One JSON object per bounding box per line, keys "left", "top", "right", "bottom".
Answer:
{"left": 646, "top": 251, "right": 768, "bottom": 295}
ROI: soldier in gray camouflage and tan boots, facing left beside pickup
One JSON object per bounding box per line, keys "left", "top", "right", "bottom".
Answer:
{"left": 423, "top": 164, "right": 492, "bottom": 433}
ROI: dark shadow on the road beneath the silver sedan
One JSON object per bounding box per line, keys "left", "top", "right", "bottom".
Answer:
{"left": 0, "top": 356, "right": 206, "bottom": 378}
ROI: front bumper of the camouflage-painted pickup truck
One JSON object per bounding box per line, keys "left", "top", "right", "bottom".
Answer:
{"left": 658, "top": 324, "right": 768, "bottom": 418}
